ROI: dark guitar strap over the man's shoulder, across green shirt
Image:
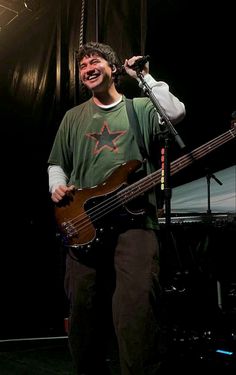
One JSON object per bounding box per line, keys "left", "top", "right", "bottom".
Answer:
{"left": 125, "top": 98, "right": 147, "bottom": 159}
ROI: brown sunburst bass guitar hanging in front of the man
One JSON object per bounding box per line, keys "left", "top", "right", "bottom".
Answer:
{"left": 55, "top": 126, "right": 236, "bottom": 248}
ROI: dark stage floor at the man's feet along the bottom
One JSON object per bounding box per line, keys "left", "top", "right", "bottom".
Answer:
{"left": 0, "top": 328, "right": 236, "bottom": 375}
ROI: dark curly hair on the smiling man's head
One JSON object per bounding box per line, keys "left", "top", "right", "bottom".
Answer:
{"left": 77, "top": 42, "right": 122, "bottom": 83}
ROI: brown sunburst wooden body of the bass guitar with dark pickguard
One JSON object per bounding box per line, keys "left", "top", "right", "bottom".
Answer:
{"left": 55, "top": 160, "right": 142, "bottom": 248}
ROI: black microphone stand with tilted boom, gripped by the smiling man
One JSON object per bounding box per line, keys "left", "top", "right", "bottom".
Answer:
{"left": 135, "top": 67, "right": 185, "bottom": 227}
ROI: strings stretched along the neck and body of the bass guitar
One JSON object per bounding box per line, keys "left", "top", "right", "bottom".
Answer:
{"left": 61, "top": 130, "right": 235, "bottom": 241}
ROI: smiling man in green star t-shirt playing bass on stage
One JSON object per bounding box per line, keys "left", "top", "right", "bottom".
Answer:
{"left": 48, "top": 42, "right": 185, "bottom": 375}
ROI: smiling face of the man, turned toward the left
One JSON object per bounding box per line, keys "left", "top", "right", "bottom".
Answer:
{"left": 79, "top": 54, "right": 114, "bottom": 92}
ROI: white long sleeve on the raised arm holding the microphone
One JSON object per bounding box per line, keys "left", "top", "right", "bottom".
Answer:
{"left": 139, "top": 73, "right": 186, "bottom": 124}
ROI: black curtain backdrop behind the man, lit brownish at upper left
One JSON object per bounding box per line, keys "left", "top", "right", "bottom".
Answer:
{"left": 0, "top": 0, "right": 236, "bottom": 338}
